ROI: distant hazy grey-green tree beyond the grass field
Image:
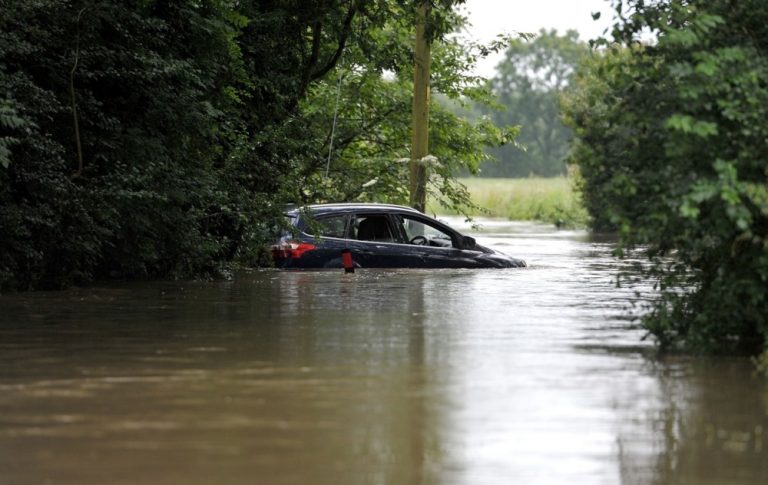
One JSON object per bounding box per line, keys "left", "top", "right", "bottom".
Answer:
{"left": 480, "top": 30, "right": 589, "bottom": 177}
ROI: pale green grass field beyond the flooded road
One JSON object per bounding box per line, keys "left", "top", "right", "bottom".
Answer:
{"left": 429, "top": 177, "right": 588, "bottom": 227}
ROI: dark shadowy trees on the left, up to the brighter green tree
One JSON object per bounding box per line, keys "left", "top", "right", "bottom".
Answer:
{"left": 0, "top": 0, "right": 372, "bottom": 288}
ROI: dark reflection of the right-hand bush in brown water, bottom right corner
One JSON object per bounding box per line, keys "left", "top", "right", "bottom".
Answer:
{"left": 618, "top": 357, "right": 768, "bottom": 484}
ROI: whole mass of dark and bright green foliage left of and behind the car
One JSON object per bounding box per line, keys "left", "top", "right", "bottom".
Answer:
{"left": 0, "top": 0, "right": 513, "bottom": 290}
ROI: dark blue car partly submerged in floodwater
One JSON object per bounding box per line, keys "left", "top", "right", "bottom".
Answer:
{"left": 272, "top": 203, "right": 526, "bottom": 270}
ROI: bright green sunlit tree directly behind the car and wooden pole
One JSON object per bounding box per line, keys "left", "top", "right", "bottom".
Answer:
{"left": 276, "top": 0, "right": 515, "bottom": 212}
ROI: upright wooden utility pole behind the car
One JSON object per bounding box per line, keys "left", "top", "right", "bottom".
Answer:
{"left": 408, "top": 0, "right": 432, "bottom": 212}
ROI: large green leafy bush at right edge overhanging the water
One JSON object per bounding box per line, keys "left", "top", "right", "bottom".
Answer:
{"left": 567, "top": 0, "right": 768, "bottom": 353}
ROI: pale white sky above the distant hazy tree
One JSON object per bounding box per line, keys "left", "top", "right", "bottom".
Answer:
{"left": 462, "top": 0, "right": 613, "bottom": 77}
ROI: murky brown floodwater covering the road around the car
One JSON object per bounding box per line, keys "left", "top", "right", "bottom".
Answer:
{"left": 0, "top": 220, "right": 768, "bottom": 485}
